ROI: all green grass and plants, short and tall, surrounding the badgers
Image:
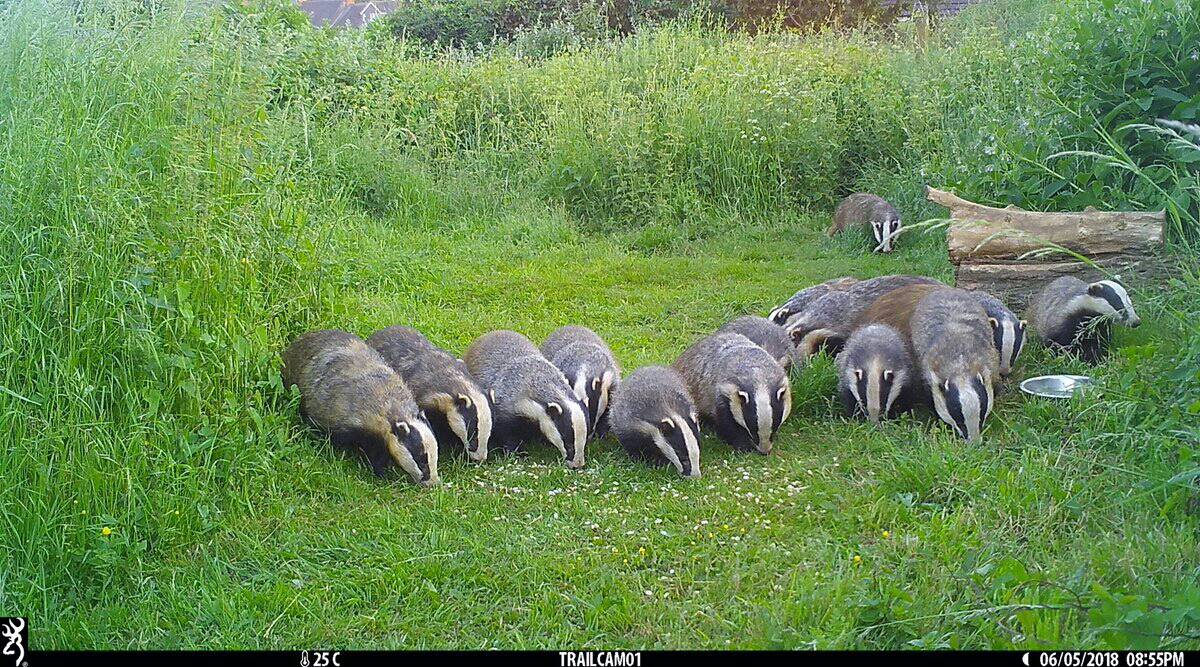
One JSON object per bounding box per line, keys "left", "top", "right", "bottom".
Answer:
{"left": 0, "top": 0, "right": 1200, "bottom": 648}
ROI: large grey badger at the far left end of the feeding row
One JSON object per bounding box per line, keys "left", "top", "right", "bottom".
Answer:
{"left": 281, "top": 330, "right": 440, "bottom": 486}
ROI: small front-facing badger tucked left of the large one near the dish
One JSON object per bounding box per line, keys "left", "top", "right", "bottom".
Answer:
{"left": 838, "top": 324, "right": 919, "bottom": 423}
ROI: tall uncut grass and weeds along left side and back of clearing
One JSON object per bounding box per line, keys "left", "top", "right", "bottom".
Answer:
{"left": 0, "top": 0, "right": 1196, "bottom": 643}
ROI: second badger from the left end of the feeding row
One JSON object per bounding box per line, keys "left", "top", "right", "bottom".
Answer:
{"left": 367, "top": 326, "right": 492, "bottom": 462}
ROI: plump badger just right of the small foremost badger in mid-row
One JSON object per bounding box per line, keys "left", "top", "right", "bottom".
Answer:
{"left": 672, "top": 334, "right": 792, "bottom": 453}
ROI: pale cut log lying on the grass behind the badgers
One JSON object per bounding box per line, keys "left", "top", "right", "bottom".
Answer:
{"left": 925, "top": 187, "right": 1169, "bottom": 310}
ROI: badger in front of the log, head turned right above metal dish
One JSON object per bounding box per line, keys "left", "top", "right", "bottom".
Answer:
{"left": 1030, "top": 276, "right": 1141, "bottom": 363}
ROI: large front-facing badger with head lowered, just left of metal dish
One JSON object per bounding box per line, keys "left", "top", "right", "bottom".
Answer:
{"left": 911, "top": 288, "right": 1000, "bottom": 440}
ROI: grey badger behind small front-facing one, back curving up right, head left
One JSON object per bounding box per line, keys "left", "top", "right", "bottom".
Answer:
{"left": 786, "top": 275, "right": 946, "bottom": 361}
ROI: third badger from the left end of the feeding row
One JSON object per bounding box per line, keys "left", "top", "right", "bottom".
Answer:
{"left": 463, "top": 331, "right": 588, "bottom": 468}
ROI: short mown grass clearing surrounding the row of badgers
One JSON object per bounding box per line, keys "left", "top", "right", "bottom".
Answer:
{"left": 34, "top": 206, "right": 1198, "bottom": 648}
